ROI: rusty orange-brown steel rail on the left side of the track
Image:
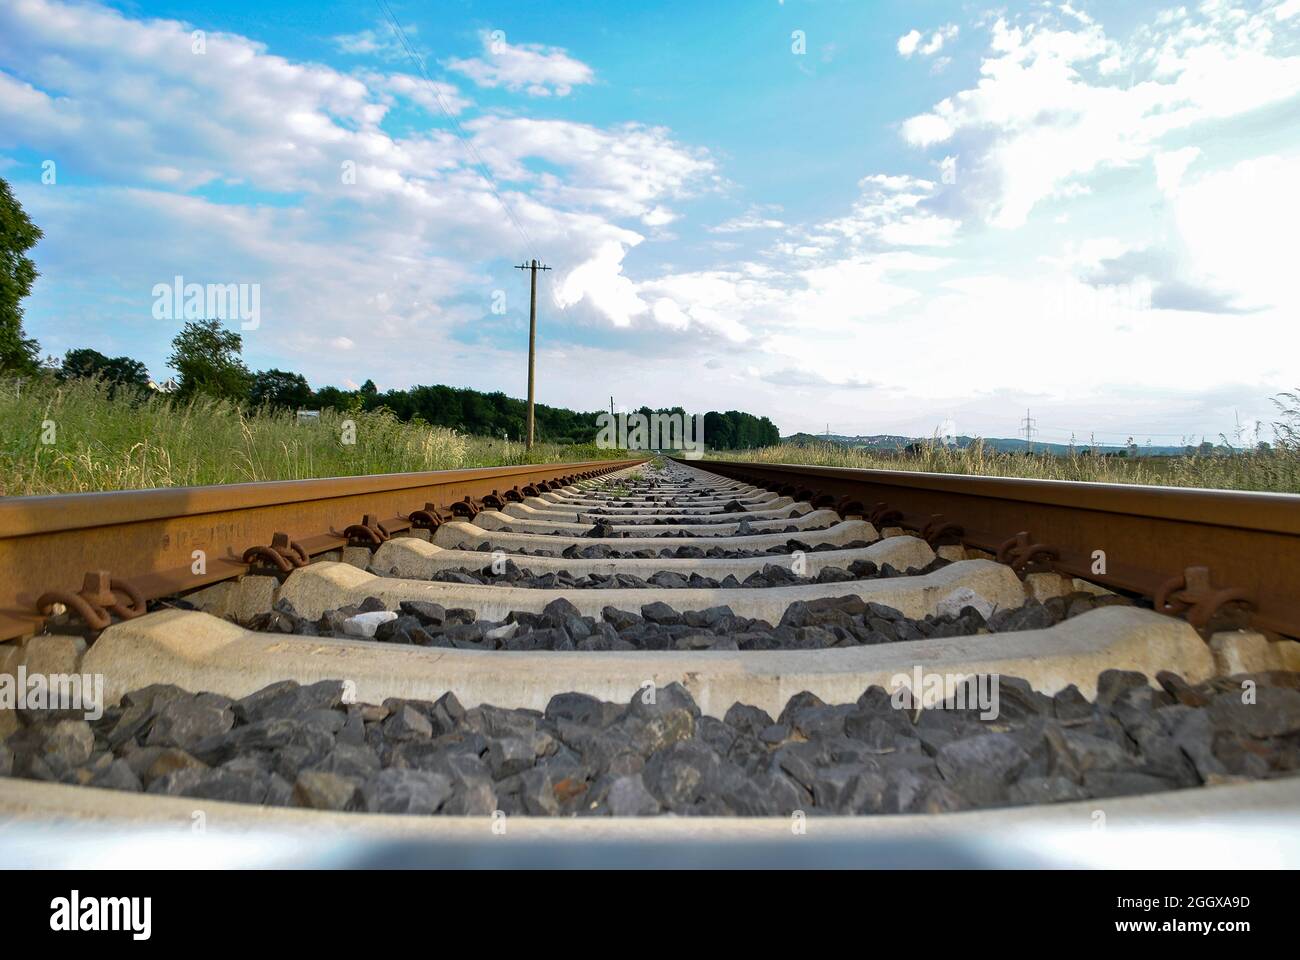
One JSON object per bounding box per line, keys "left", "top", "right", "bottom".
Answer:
{"left": 0, "top": 458, "right": 644, "bottom": 640}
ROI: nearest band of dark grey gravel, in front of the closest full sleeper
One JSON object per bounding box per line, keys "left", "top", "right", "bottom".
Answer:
{"left": 0, "top": 670, "right": 1300, "bottom": 817}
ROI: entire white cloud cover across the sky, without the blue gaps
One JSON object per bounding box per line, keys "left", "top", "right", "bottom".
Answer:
{"left": 0, "top": 0, "right": 1300, "bottom": 434}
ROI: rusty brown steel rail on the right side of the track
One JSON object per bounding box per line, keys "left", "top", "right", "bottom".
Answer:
{"left": 684, "top": 460, "right": 1300, "bottom": 637}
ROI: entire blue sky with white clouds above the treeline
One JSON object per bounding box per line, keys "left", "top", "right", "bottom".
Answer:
{"left": 0, "top": 0, "right": 1300, "bottom": 442}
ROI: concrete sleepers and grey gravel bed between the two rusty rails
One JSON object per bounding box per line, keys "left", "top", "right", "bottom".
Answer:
{"left": 0, "top": 464, "right": 1300, "bottom": 818}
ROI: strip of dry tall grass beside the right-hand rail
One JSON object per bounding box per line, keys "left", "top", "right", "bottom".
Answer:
{"left": 707, "top": 393, "right": 1300, "bottom": 493}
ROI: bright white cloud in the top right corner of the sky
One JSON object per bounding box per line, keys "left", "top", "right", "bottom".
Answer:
{"left": 902, "top": 10, "right": 1300, "bottom": 226}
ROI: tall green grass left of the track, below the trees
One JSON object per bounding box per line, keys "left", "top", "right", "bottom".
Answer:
{"left": 0, "top": 379, "right": 625, "bottom": 496}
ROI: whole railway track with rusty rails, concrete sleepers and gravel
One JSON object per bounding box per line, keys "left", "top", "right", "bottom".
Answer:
{"left": 0, "top": 459, "right": 1300, "bottom": 836}
